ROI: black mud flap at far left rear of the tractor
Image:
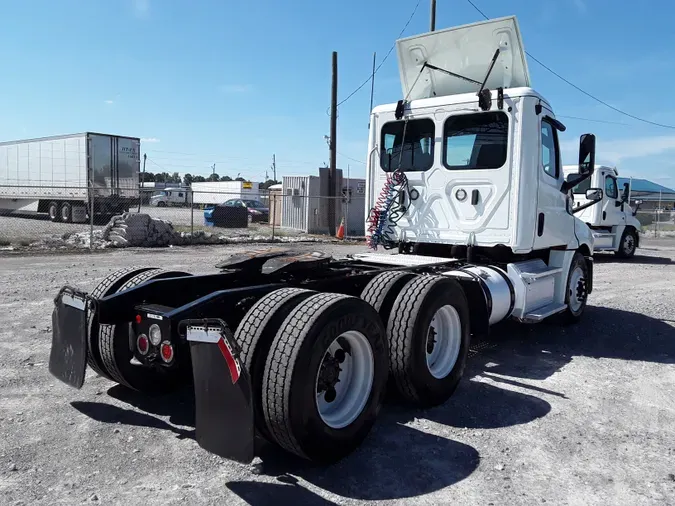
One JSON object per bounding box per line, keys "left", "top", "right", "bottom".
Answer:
{"left": 49, "top": 287, "right": 94, "bottom": 388}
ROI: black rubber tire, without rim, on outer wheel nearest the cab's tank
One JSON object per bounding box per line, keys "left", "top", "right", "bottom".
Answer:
{"left": 387, "top": 276, "right": 470, "bottom": 407}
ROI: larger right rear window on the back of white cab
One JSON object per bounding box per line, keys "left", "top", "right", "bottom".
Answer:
{"left": 443, "top": 112, "right": 509, "bottom": 170}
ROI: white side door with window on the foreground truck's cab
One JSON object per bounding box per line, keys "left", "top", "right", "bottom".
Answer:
{"left": 536, "top": 114, "right": 574, "bottom": 249}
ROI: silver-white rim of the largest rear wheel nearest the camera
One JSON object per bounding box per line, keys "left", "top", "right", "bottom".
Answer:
{"left": 315, "top": 330, "right": 375, "bottom": 429}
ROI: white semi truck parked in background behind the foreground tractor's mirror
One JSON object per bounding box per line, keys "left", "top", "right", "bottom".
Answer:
{"left": 563, "top": 166, "right": 641, "bottom": 258}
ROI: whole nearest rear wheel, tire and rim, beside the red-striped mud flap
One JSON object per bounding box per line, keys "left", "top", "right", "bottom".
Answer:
{"left": 262, "top": 293, "right": 388, "bottom": 464}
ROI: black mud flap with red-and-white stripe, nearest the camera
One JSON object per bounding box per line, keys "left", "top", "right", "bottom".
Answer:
{"left": 180, "top": 319, "right": 255, "bottom": 463}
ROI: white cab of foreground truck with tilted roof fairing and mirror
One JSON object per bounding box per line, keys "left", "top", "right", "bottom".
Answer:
{"left": 367, "top": 17, "right": 594, "bottom": 258}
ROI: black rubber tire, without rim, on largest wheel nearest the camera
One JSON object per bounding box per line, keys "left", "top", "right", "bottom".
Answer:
{"left": 262, "top": 293, "right": 387, "bottom": 464}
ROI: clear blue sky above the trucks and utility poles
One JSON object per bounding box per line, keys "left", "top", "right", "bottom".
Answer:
{"left": 0, "top": 0, "right": 675, "bottom": 187}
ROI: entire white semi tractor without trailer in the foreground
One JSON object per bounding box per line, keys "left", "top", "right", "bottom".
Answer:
{"left": 49, "top": 17, "right": 599, "bottom": 463}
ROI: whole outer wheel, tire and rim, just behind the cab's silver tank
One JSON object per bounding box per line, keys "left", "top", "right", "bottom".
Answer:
{"left": 387, "top": 276, "right": 470, "bottom": 407}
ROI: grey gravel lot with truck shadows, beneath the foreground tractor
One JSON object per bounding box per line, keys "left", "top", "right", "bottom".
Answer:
{"left": 0, "top": 242, "right": 675, "bottom": 506}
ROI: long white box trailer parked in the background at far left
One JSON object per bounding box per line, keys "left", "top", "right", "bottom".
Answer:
{"left": 0, "top": 132, "right": 141, "bottom": 223}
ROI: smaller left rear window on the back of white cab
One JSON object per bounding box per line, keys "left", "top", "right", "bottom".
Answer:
{"left": 380, "top": 119, "right": 435, "bottom": 172}
